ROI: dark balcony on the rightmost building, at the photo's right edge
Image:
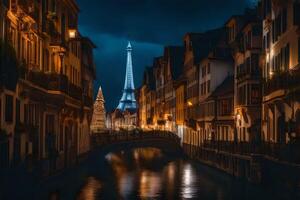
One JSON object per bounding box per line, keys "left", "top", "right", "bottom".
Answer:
{"left": 264, "top": 67, "right": 300, "bottom": 96}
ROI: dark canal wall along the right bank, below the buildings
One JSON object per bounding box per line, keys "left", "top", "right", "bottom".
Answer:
{"left": 182, "top": 143, "right": 300, "bottom": 191}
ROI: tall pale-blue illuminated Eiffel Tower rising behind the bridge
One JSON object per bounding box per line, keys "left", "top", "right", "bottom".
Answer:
{"left": 117, "top": 42, "right": 137, "bottom": 112}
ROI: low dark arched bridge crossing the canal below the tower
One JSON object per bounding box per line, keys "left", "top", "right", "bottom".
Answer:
{"left": 91, "top": 131, "right": 181, "bottom": 153}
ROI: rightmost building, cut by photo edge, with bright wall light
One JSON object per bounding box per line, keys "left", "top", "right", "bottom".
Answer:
{"left": 262, "top": 0, "right": 300, "bottom": 144}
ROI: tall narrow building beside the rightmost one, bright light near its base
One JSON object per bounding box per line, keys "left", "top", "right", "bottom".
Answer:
{"left": 234, "top": 16, "right": 262, "bottom": 142}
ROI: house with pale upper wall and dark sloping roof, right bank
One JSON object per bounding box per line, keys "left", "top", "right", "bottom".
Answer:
{"left": 196, "top": 42, "right": 234, "bottom": 143}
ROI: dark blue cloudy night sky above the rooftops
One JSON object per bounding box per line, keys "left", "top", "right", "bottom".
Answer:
{"left": 77, "top": 0, "right": 255, "bottom": 111}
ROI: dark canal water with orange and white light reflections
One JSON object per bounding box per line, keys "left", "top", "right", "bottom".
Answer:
{"left": 0, "top": 148, "right": 290, "bottom": 200}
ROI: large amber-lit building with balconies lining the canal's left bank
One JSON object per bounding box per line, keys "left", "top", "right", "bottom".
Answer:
{"left": 0, "top": 0, "right": 95, "bottom": 171}
